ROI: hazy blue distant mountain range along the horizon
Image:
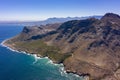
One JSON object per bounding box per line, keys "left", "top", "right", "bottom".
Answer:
{"left": 0, "top": 16, "right": 102, "bottom": 26}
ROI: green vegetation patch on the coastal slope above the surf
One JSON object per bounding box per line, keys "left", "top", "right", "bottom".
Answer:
{"left": 15, "top": 40, "right": 70, "bottom": 63}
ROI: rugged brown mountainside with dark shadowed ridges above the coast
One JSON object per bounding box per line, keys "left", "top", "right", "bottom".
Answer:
{"left": 6, "top": 13, "right": 120, "bottom": 80}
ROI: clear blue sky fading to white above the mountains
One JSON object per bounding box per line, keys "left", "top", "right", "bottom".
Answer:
{"left": 0, "top": 0, "right": 120, "bottom": 21}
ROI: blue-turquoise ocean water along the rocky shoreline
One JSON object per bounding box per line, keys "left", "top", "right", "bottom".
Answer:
{"left": 0, "top": 25, "right": 83, "bottom": 80}
